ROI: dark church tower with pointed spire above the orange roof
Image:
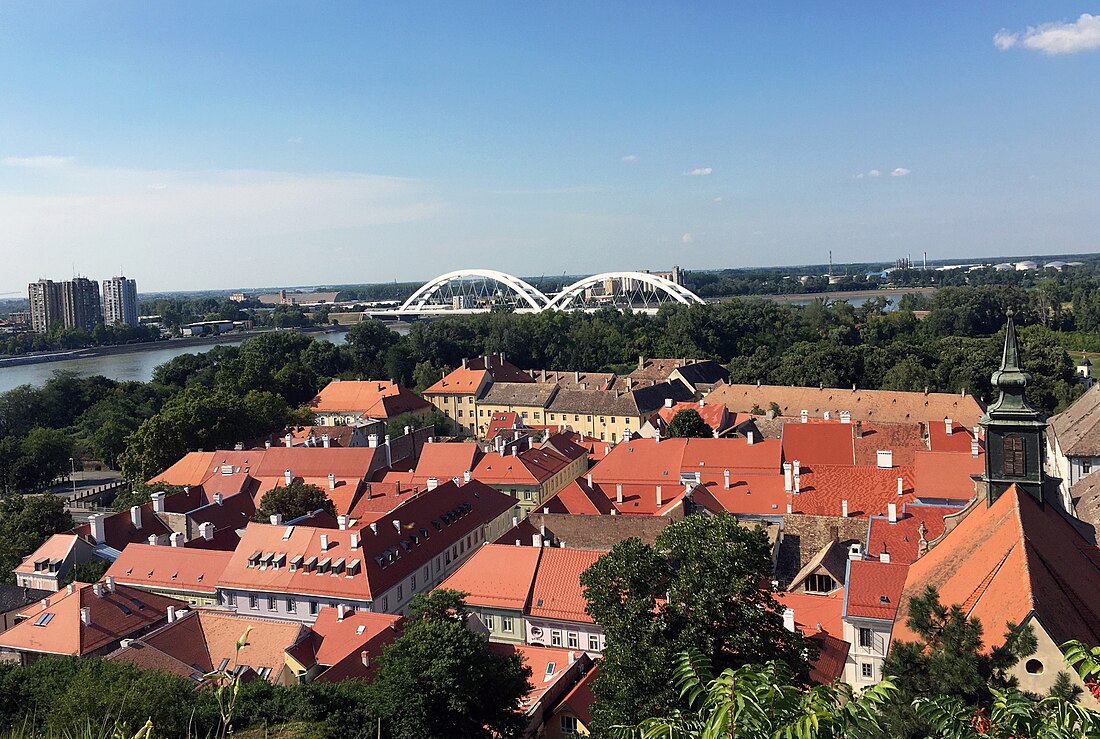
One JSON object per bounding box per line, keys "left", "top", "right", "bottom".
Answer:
{"left": 981, "top": 308, "right": 1046, "bottom": 504}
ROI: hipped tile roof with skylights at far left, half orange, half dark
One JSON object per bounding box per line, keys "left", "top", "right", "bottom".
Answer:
{"left": 0, "top": 583, "right": 187, "bottom": 655}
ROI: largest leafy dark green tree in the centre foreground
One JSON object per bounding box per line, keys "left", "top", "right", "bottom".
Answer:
{"left": 581, "top": 514, "right": 809, "bottom": 736}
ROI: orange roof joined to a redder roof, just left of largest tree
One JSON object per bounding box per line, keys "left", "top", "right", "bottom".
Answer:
{"left": 439, "top": 544, "right": 542, "bottom": 610}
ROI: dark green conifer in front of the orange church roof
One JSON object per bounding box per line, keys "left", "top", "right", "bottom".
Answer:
{"left": 882, "top": 585, "right": 1037, "bottom": 739}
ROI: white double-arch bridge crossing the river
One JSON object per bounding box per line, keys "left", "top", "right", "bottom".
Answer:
{"left": 369, "top": 269, "right": 704, "bottom": 319}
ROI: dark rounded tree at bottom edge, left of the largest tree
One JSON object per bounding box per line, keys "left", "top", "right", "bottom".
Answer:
{"left": 367, "top": 591, "right": 531, "bottom": 739}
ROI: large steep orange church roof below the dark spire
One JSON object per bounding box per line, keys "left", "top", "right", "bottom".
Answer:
{"left": 893, "top": 486, "right": 1100, "bottom": 649}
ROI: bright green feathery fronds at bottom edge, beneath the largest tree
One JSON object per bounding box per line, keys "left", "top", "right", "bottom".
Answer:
{"left": 613, "top": 649, "right": 895, "bottom": 739}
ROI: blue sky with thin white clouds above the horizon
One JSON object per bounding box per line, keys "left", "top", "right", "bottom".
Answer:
{"left": 0, "top": 0, "right": 1100, "bottom": 294}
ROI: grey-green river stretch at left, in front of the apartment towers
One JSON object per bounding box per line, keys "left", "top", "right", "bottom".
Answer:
{"left": 0, "top": 331, "right": 344, "bottom": 393}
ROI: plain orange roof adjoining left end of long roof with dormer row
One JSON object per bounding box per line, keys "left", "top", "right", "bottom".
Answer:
{"left": 107, "top": 544, "right": 232, "bottom": 597}
